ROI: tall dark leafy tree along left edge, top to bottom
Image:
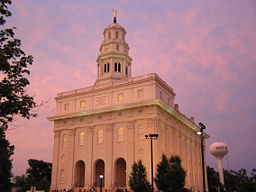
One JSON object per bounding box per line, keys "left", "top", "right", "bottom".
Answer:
{"left": 0, "top": 0, "right": 36, "bottom": 192}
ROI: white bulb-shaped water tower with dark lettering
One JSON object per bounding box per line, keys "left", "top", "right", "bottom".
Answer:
{"left": 210, "top": 142, "right": 228, "bottom": 185}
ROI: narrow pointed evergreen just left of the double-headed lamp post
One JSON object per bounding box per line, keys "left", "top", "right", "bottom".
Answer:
{"left": 129, "top": 160, "right": 150, "bottom": 192}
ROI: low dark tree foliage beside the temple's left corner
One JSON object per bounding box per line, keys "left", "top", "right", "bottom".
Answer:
{"left": 14, "top": 159, "right": 52, "bottom": 192}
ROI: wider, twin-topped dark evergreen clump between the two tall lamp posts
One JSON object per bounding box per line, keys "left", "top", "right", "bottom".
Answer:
{"left": 155, "top": 154, "right": 186, "bottom": 192}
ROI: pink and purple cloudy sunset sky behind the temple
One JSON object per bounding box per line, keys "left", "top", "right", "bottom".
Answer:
{"left": 4, "top": 0, "right": 256, "bottom": 175}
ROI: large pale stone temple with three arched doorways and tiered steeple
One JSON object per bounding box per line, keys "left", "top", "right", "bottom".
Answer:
{"left": 48, "top": 12, "right": 208, "bottom": 192}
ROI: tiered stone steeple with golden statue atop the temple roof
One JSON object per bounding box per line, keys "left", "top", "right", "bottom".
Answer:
{"left": 95, "top": 9, "right": 132, "bottom": 85}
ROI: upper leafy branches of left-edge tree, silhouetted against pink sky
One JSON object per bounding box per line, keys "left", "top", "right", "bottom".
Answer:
{"left": 0, "top": 0, "right": 36, "bottom": 131}
